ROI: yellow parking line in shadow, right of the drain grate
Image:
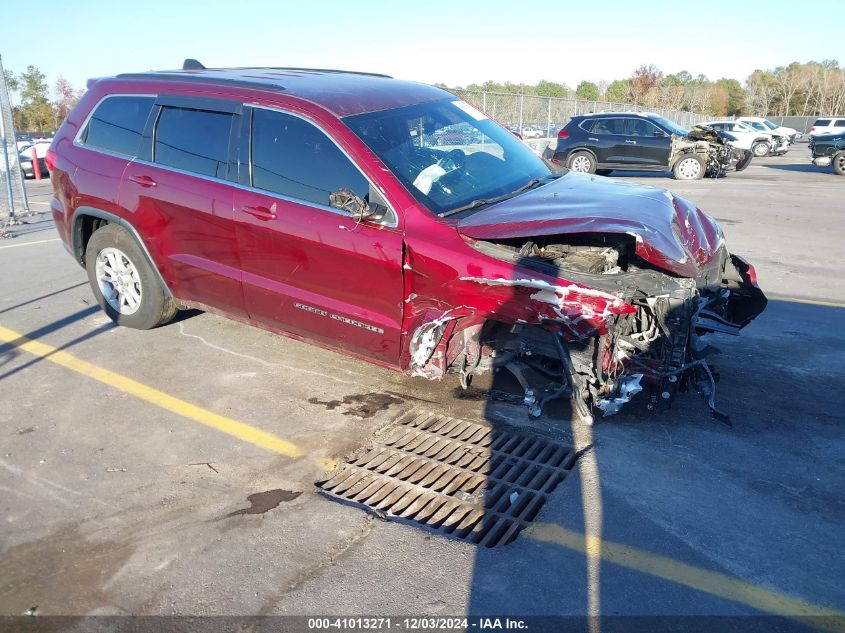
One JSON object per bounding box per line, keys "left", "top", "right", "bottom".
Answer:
{"left": 523, "top": 523, "right": 845, "bottom": 633}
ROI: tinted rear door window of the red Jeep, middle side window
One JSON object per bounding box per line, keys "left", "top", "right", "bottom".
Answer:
{"left": 153, "top": 106, "right": 233, "bottom": 178}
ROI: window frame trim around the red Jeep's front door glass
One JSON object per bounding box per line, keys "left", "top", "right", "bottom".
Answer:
{"left": 237, "top": 103, "right": 399, "bottom": 229}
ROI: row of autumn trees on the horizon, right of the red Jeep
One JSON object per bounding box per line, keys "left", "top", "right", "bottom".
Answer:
{"left": 443, "top": 59, "right": 845, "bottom": 116}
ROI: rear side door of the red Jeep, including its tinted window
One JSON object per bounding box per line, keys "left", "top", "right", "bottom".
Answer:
{"left": 120, "top": 95, "right": 246, "bottom": 316}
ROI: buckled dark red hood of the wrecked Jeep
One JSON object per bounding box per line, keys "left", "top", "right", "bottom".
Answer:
{"left": 457, "top": 172, "right": 724, "bottom": 278}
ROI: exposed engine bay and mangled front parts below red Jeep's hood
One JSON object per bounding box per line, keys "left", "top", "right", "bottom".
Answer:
{"left": 448, "top": 232, "right": 766, "bottom": 423}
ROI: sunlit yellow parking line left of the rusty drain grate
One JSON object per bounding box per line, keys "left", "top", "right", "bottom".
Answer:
{"left": 0, "top": 326, "right": 304, "bottom": 457}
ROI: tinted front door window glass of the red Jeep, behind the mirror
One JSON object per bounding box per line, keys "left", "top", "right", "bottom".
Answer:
{"left": 251, "top": 108, "right": 370, "bottom": 207}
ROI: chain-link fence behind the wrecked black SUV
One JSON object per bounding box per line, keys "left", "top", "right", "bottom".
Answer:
{"left": 451, "top": 90, "right": 714, "bottom": 138}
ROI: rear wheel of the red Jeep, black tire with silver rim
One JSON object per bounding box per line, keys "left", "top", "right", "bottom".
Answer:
{"left": 85, "top": 224, "right": 179, "bottom": 330}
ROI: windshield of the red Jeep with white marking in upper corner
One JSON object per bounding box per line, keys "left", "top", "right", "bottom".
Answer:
{"left": 344, "top": 99, "right": 551, "bottom": 215}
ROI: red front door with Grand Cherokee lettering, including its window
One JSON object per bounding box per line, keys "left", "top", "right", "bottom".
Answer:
{"left": 234, "top": 107, "right": 404, "bottom": 364}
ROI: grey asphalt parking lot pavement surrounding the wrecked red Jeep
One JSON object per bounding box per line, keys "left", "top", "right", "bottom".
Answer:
{"left": 0, "top": 144, "right": 845, "bottom": 630}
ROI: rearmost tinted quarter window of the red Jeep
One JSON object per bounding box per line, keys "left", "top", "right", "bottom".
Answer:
{"left": 79, "top": 96, "right": 155, "bottom": 156}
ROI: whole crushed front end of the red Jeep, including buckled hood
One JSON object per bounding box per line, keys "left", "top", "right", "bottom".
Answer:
{"left": 408, "top": 175, "right": 766, "bottom": 423}
